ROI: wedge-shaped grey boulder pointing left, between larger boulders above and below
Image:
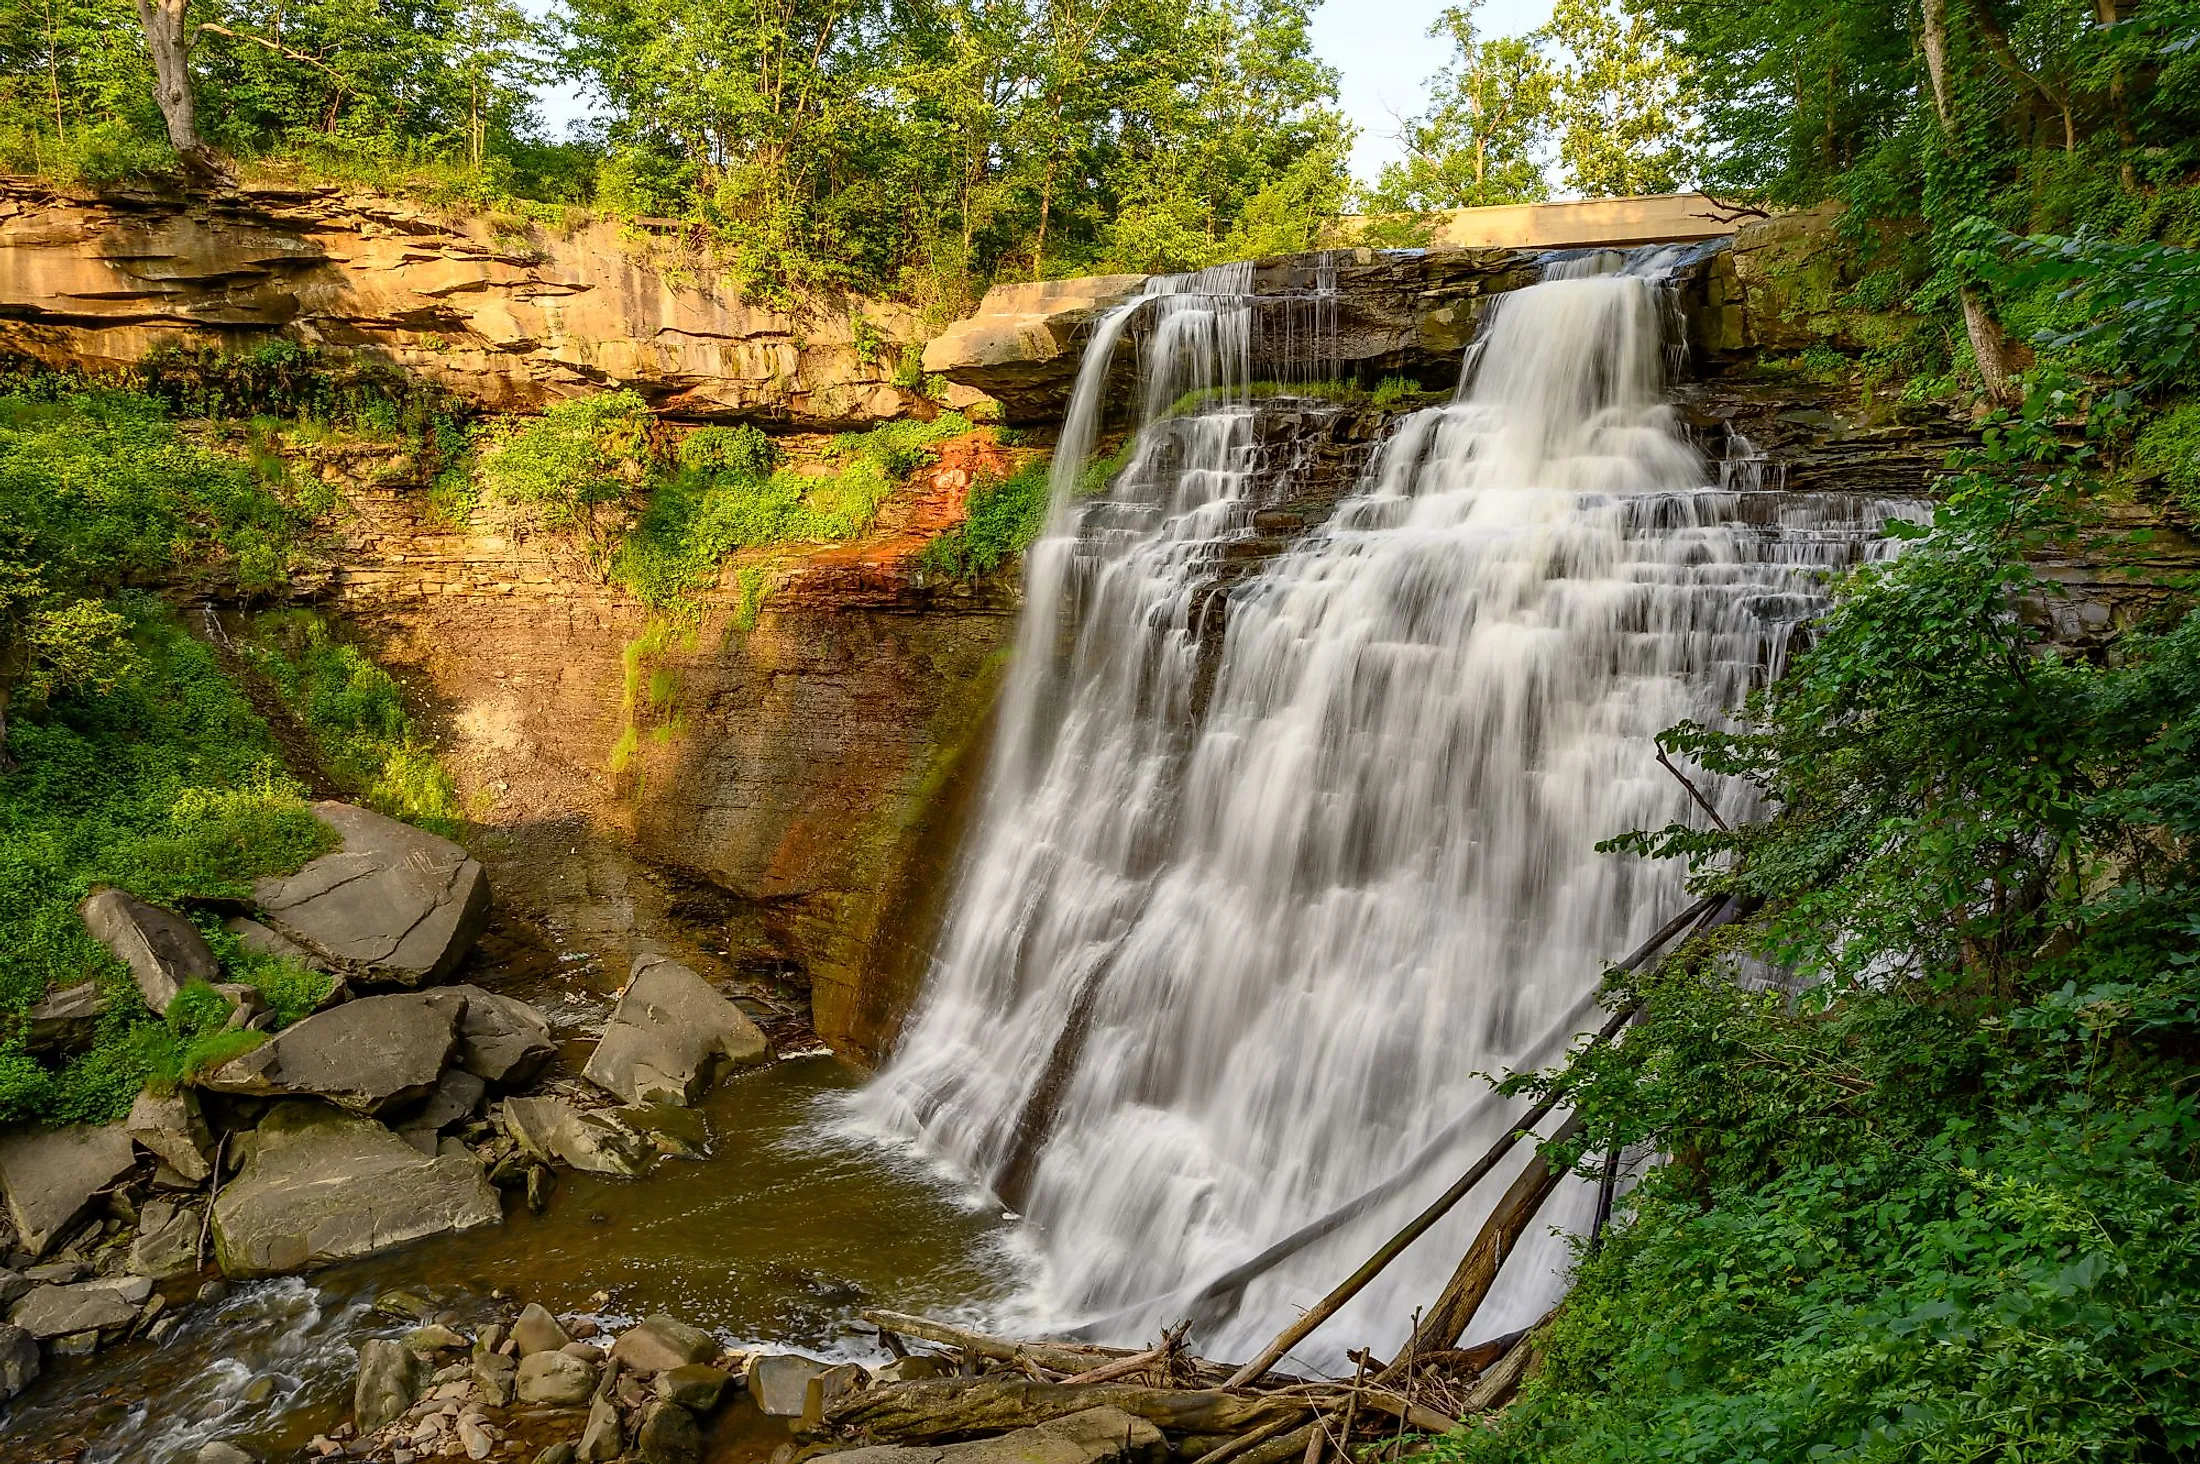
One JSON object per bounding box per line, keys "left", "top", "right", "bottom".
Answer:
{"left": 200, "top": 988, "right": 466, "bottom": 1114}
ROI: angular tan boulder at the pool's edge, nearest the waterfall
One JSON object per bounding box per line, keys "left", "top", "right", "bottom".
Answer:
{"left": 583, "top": 955, "right": 772, "bottom": 1105}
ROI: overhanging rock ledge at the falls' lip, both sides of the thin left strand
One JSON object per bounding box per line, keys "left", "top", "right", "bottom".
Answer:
{"left": 924, "top": 249, "right": 1536, "bottom": 423}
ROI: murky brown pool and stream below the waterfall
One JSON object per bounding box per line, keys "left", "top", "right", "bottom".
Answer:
{"left": 0, "top": 1057, "right": 1016, "bottom": 1464}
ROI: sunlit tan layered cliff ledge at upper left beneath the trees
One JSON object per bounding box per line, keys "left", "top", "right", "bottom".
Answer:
{"left": 0, "top": 183, "right": 915, "bottom": 427}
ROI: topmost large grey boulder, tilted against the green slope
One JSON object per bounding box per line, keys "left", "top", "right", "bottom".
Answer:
{"left": 253, "top": 804, "right": 488, "bottom": 986}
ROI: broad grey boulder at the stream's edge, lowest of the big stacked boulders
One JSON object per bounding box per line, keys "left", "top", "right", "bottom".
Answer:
{"left": 213, "top": 1103, "right": 504, "bottom": 1277}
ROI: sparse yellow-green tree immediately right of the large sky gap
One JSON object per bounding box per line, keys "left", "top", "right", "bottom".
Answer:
{"left": 1368, "top": 0, "right": 1558, "bottom": 214}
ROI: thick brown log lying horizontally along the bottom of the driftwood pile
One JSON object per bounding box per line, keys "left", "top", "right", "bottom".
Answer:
{"left": 821, "top": 1378, "right": 1309, "bottom": 1444}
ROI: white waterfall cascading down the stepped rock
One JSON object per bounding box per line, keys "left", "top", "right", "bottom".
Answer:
{"left": 865, "top": 260, "right": 1888, "bottom": 1367}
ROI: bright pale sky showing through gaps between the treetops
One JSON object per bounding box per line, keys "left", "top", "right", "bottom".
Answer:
{"left": 524, "top": 0, "right": 1551, "bottom": 183}
